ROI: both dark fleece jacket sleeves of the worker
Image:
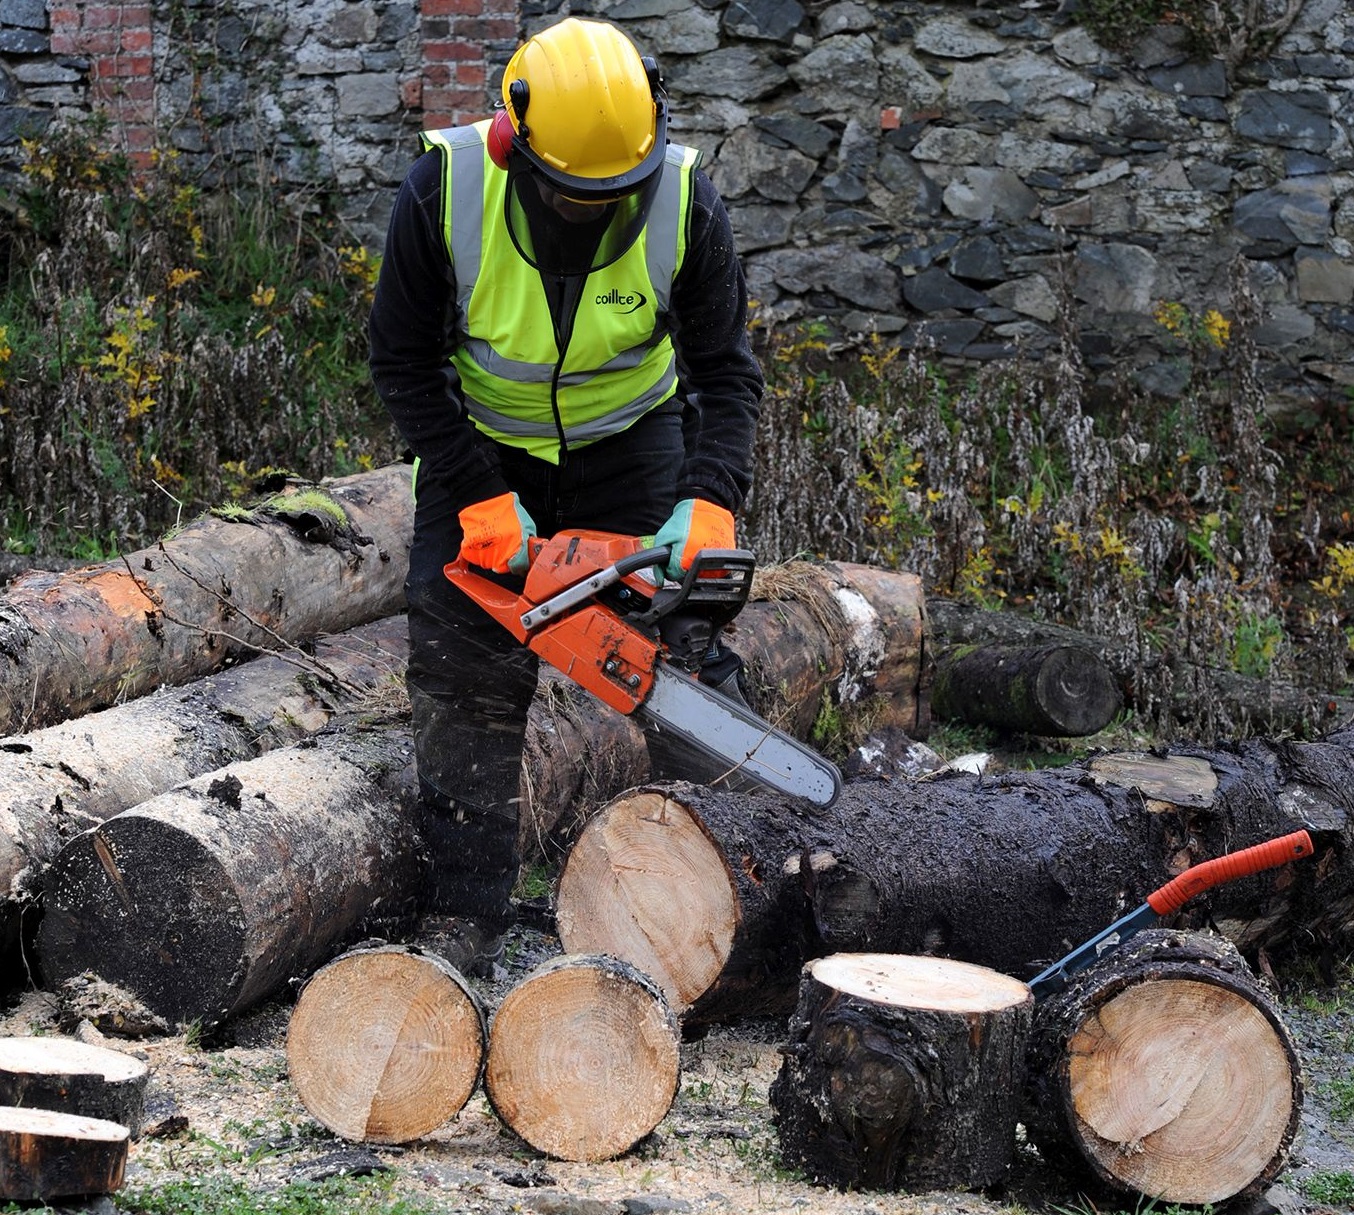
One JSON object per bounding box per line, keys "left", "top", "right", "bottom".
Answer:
{"left": 368, "top": 149, "right": 764, "bottom": 511}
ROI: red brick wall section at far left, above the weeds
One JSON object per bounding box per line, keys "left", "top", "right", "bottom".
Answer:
{"left": 49, "top": 0, "right": 154, "bottom": 164}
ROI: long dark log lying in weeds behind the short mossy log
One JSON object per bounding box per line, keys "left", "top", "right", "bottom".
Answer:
{"left": 926, "top": 596, "right": 1354, "bottom": 738}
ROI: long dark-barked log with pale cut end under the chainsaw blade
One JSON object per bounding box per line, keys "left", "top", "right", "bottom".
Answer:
{"left": 556, "top": 734, "right": 1354, "bottom": 1023}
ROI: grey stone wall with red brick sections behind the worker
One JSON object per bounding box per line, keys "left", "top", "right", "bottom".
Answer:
{"left": 0, "top": 0, "right": 1354, "bottom": 408}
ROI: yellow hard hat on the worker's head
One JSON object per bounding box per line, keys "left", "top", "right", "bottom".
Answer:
{"left": 498, "top": 18, "right": 668, "bottom": 202}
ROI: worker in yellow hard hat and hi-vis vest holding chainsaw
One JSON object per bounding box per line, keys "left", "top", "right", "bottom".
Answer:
{"left": 370, "top": 18, "right": 764, "bottom": 975}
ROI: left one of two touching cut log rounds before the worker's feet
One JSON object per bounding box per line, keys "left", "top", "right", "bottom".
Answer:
{"left": 287, "top": 945, "right": 487, "bottom": 1143}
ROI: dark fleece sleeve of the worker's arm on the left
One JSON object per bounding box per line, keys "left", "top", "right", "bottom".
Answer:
{"left": 367, "top": 149, "right": 508, "bottom": 509}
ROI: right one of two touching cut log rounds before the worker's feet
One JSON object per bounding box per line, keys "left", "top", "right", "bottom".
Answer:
{"left": 485, "top": 955, "right": 681, "bottom": 1162}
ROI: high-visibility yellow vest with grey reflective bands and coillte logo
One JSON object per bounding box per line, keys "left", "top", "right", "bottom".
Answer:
{"left": 424, "top": 122, "right": 700, "bottom": 463}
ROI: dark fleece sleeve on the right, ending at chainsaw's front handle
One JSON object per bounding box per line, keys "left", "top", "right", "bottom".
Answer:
{"left": 672, "top": 171, "right": 765, "bottom": 511}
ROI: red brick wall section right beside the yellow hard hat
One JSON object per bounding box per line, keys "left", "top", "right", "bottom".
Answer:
{"left": 420, "top": 0, "right": 519, "bottom": 130}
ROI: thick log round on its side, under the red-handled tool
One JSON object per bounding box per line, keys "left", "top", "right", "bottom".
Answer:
{"left": 1025, "top": 929, "right": 1303, "bottom": 1204}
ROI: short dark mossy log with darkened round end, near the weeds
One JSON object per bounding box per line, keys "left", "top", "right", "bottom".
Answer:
{"left": 932, "top": 645, "right": 1121, "bottom": 738}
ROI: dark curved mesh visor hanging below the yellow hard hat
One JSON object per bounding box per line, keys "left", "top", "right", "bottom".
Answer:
{"left": 504, "top": 156, "right": 662, "bottom": 276}
